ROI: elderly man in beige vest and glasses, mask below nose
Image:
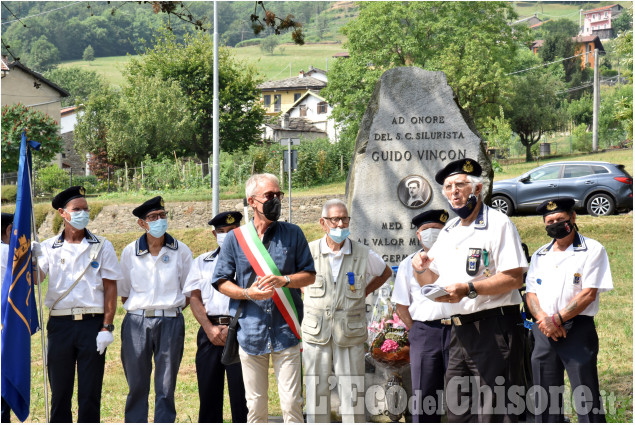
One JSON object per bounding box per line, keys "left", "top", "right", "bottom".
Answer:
{"left": 302, "top": 199, "right": 392, "bottom": 423}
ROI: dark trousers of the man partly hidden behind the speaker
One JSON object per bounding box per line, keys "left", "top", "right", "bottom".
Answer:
{"left": 408, "top": 320, "right": 452, "bottom": 423}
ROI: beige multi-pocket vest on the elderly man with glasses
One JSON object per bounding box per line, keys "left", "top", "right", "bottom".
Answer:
{"left": 302, "top": 239, "right": 369, "bottom": 347}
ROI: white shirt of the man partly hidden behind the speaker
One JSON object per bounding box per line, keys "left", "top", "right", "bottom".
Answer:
{"left": 391, "top": 253, "right": 450, "bottom": 322}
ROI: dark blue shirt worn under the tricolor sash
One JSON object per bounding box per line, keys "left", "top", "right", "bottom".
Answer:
{"left": 212, "top": 220, "right": 315, "bottom": 355}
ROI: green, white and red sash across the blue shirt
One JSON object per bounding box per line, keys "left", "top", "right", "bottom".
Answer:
{"left": 234, "top": 221, "right": 302, "bottom": 340}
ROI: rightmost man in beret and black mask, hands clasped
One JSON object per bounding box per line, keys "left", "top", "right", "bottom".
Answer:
{"left": 527, "top": 198, "right": 613, "bottom": 422}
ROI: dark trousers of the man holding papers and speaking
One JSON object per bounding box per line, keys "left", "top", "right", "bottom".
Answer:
{"left": 445, "top": 308, "right": 525, "bottom": 422}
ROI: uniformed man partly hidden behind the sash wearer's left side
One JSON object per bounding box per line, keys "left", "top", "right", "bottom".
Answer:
{"left": 183, "top": 211, "right": 247, "bottom": 423}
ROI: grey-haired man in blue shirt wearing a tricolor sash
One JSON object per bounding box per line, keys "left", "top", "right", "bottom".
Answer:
{"left": 212, "top": 174, "right": 315, "bottom": 423}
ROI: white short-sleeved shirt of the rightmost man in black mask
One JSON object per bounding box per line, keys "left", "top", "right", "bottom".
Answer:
{"left": 526, "top": 233, "right": 613, "bottom": 316}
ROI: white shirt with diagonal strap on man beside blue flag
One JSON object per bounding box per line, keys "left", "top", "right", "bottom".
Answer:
{"left": 38, "top": 229, "right": 123, "bottom": 310}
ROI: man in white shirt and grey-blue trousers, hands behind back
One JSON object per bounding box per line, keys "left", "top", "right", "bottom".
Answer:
{"left": 117, "top": 196, "right": 192, "bottom": 423}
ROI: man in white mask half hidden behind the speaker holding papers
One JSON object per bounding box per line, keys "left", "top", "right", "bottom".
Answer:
{"left": 392, "top": 210, "right": 452, "bottom": 423}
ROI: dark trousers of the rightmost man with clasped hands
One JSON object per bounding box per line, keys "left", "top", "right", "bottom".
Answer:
{"left": 531, "top": 316, "right": 606, "bottom": 422}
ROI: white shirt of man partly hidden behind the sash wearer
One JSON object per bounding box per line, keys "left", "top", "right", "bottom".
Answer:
{"left": 183, "top": 248, "right": 229, "bottom": 316}
